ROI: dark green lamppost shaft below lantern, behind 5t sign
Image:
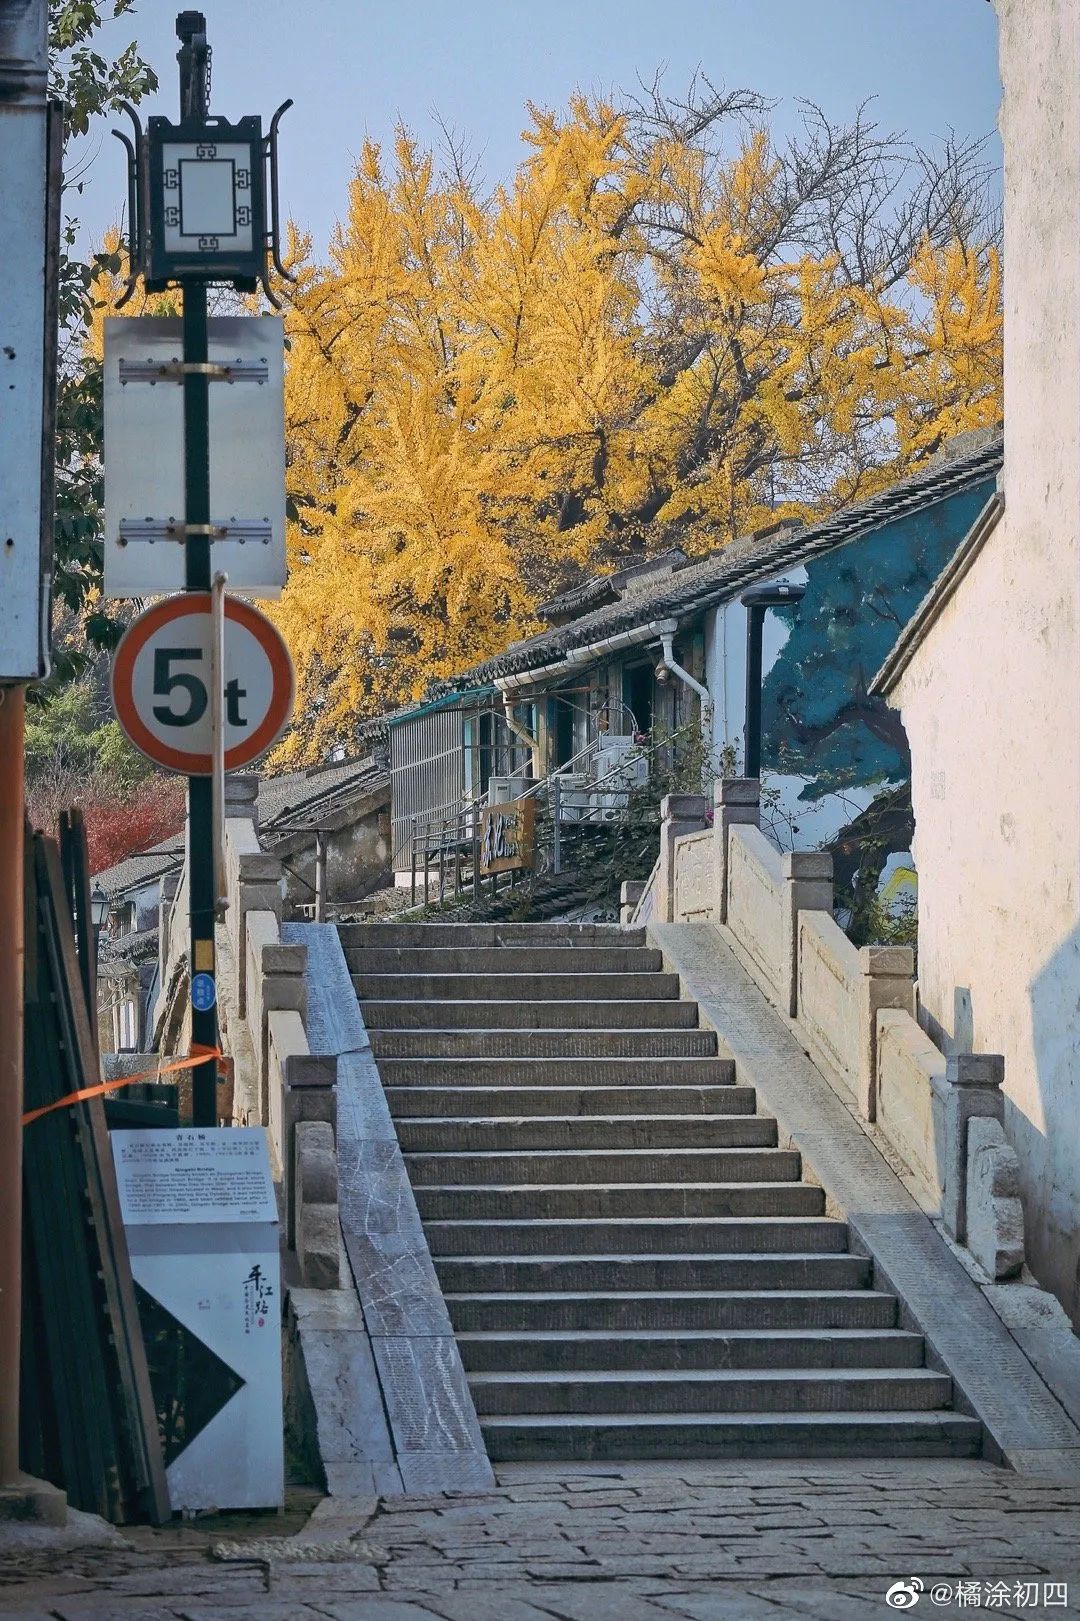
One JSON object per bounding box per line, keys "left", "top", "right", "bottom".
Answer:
{"left": 183, "top": 282, "right": 217, "bottom": 1127}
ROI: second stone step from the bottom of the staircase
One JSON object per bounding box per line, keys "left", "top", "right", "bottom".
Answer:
{"left": 469, "top": 1368, "right": 952, "bottom": 1418}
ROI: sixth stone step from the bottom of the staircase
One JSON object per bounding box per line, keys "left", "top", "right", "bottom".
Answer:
{"left": 425, "top": 1213, "right": 848, "bottom": 1258}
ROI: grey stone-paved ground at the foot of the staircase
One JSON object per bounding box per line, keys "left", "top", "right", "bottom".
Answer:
{"left": 0, "top": 1461, "right": 1080, "bottom": 1621}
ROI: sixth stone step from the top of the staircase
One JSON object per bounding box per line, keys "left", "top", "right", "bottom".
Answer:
{"left": 379, "top": 1057, "right": 735, "bottom": 1089}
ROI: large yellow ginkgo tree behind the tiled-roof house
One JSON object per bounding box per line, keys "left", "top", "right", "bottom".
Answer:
{"left": 276, "top": 86, "right": 1001, "bottom": 760}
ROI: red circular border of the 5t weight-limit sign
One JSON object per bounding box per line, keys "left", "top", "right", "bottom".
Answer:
{"left": 109, "top": 592, "right": 295, "bottom": 776}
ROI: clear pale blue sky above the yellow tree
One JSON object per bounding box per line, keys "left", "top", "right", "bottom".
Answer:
{"left": 73, "top": 0, "right": 1001, "bottom": 248}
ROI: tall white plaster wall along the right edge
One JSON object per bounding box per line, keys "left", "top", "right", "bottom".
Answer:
{"left": 894, "top": 0, "right": 1080, "bottom": 1316}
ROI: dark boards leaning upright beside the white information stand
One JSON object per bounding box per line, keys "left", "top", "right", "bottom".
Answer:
{"left": 21, "top": 812, "right": 169, "bottom": 1524}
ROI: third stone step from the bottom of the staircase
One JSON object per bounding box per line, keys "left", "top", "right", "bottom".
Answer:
{"left": 457, "top": 1328, "right": 924, "bottom": 1373}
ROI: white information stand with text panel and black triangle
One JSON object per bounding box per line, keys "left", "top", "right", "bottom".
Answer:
{"left": 110, "top": 1127, "right": 284, "bottom": 1511}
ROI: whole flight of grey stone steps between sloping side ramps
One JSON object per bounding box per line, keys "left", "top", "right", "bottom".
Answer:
{"left": 341, "top": 922, "right": 981, "bottom": 1461}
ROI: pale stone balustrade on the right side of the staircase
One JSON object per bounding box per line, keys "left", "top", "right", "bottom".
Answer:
{"left": 654, "top": 778, "right": 1023, "bottom": 1277}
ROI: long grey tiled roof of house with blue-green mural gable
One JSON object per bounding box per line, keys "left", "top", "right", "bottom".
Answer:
{"left": 431, "top": 428, "right": 1004, "bottom": 694}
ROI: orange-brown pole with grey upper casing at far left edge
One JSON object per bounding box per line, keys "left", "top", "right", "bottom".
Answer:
{"left": 0, "top": 0, "right": 63, "bottom": 1517}
